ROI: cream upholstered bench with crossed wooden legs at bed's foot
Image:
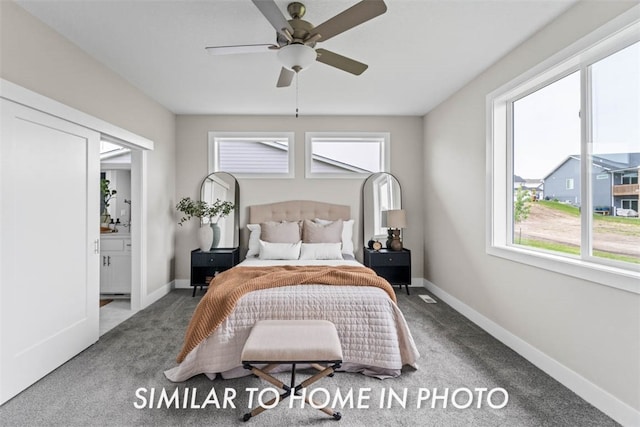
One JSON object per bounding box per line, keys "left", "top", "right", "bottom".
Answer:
{"left": 242, "top": 320, "right": 342, "bottom": 421}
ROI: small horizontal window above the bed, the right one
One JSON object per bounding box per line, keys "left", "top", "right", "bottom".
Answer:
{"left": 305, "top": 132, "right": 390, "bottom": 178}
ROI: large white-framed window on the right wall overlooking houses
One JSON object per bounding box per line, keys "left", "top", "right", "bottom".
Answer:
{"left": 487, "top": 14, "right": 640, "bottom": 293}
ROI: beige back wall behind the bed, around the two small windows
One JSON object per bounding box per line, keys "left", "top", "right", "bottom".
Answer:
{"left": 176, "top": 116, "right": 423, "bottom": 279}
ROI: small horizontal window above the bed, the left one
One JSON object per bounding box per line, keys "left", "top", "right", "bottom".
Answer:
{"left": 209, "top": 132, "right": 294, "bottom": 178}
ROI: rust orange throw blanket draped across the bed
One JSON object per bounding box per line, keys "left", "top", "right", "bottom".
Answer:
{"left": 178, "top": 266, "right": 396, "bottom": 363}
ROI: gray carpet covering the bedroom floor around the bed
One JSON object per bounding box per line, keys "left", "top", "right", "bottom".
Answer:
{"left": 0, "top": 289, "right": 617, "bottom": 427}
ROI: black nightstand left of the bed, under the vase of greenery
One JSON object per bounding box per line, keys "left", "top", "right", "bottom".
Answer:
{"left": 191, "top": 248, "right": 240, "bottom": 297}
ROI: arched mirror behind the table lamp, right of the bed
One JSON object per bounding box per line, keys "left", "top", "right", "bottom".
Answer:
{"left": 362, "top": 172, "right": 402, "bottom": 246}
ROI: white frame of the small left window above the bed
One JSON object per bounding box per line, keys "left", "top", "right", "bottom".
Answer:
{"left": 208, "top": 131, "right": 295, "bottom": 179}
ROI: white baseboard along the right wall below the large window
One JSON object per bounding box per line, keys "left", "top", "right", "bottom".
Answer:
{"left": 423, "top": 279, "right": 640, "bottom": 426}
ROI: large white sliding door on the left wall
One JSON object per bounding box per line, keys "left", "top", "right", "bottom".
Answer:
{"left": 0, "top": 99, "right": 100, "bottom": 404}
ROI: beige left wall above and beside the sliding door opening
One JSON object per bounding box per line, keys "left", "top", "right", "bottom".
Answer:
{"left": 0, "top": 1, "right": 175, "bottom": 300}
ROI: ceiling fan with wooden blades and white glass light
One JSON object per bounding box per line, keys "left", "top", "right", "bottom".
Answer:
{"left": 205, "top": 0, "right": 387, "bottom": 87}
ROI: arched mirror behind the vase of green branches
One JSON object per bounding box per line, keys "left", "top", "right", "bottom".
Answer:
{"left": 200, "top": 172, "right": 240, "bottom": 248}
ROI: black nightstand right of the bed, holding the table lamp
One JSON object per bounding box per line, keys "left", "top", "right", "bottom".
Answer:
{"left": 364, "top": 248, "right": 411, "bottom": 295}
